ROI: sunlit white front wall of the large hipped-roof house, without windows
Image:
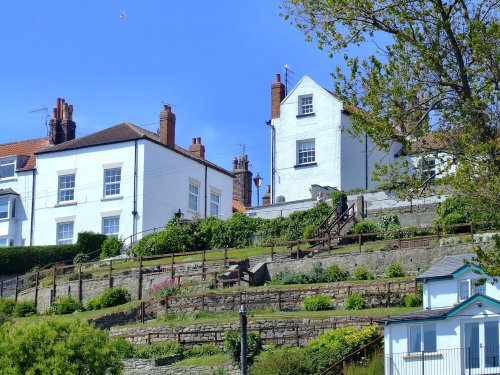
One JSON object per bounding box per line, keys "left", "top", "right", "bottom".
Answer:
{"left": 34, "top": 141, "right": 139, "bottom": 245}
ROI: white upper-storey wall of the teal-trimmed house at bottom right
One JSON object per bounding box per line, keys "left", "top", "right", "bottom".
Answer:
{"left": 423, "top": 270, "right": 500, "bottom": 309}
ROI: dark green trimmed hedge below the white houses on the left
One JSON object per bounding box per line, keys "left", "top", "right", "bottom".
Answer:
{"left": 0, "top": 232, "right": 107, "bottom": 275}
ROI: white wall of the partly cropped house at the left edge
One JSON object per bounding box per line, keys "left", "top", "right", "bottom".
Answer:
{"left": 0, "top": 171, "right": 33, "bottom": 246}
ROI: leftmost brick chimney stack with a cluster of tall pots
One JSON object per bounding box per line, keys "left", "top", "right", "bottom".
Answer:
{"left": 49, "top": 98, "right": 76, "bottom": 145}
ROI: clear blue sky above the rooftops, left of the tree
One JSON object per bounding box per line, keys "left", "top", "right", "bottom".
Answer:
{"left": 0, "top": 0, "right": 343, "bottom": 206}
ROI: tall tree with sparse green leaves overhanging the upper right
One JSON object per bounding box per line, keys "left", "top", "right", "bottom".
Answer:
{"left": 282, "top": 0, "right": 500, "bottom": 214}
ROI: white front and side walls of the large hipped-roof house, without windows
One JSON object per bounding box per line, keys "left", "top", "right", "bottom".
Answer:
{"left": 34, "top": 139, "right": 233, "bottom": 245}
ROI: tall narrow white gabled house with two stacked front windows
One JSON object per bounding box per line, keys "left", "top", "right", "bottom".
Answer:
{"left": 268, "top": 74, "right": 401, "bottom": 203}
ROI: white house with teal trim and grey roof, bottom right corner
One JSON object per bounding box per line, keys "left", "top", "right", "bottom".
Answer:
{"left": 379, "top": 255, "right": 500, "bottom": 375}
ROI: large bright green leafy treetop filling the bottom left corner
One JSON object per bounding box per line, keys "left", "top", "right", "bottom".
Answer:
{"left": 0, "top": 320, "right": 123, "bottom": 375}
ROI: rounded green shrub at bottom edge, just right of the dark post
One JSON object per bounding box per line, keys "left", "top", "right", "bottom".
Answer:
{"left": 250, "top": 346, "right": 313, "bottom": 375}
